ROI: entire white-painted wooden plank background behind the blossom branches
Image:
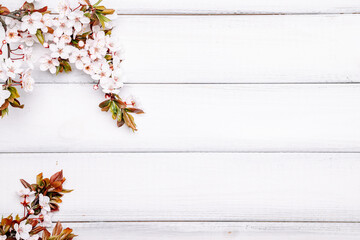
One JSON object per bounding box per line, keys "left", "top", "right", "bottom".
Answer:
{"left": 0, "top": 0, "right": 360, "bottom": 240}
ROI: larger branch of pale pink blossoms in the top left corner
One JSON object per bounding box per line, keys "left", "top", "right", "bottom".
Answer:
{"left": 0, "top": 0, "right": 143, "bottom": 130}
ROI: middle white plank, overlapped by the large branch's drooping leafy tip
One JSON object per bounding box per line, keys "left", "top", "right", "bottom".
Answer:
{"left": 0, "top": 84, "right": 360, "bottom": 152}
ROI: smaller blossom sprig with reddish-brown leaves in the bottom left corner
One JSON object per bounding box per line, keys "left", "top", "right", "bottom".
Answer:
{"left": 0, "top": 171, "right": 75, "bottom": 240}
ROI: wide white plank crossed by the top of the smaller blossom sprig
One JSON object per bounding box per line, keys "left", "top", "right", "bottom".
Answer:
{"left": 0, "top": 153, "right": 360, "bottom": 222}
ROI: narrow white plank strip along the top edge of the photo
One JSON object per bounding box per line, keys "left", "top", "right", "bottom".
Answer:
{"left": 3, "top": 0, "right": 360, "bottom": 14}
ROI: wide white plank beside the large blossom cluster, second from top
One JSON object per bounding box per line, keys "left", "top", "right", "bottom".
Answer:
{"left": 3, "top": 15, "right": 360, "bottom": 83}
